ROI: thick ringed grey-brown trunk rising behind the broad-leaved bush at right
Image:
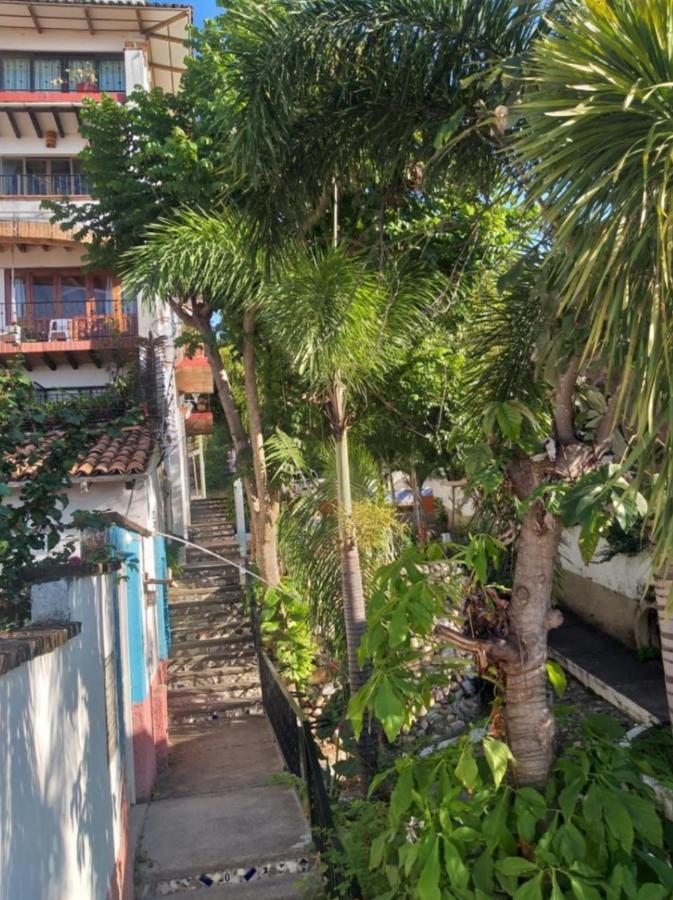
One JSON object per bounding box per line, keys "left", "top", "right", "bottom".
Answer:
{"left": 503, "top": 482, "right": 561, "bottom": 788}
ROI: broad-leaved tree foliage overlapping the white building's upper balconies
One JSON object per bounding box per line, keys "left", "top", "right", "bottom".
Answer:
{"left": 48, "top": 84, "right": 221, "bottom": 269}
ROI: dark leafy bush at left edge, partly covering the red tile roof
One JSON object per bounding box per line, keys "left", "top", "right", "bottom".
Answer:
{"left": 0, "top": 364, "right": 100, "bottom": 618}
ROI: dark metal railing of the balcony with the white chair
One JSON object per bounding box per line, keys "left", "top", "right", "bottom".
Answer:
{"left": 0, "top": 299, "right": 138, "bottom": 352}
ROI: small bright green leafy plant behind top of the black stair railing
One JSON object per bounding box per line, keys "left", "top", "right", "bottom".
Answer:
{"left": 259, "top": 579, "right": 317, "bottom": 692}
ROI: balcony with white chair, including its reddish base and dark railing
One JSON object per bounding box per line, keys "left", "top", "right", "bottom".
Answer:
{"left": 0, "top": 299, "right": 138, "bottom": 371}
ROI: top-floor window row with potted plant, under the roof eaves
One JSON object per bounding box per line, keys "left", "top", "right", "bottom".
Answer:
{"left": 0, "top": 53, "right": 125, "bottom": 93}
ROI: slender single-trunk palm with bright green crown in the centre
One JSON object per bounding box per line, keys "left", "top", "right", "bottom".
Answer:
{"left": 262, "top": 249, "right": 426, "bottom": 767}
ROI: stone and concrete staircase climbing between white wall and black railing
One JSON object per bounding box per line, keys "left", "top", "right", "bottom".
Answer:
{"left": 136, "top": 499, "right": 321, "bottom": 900}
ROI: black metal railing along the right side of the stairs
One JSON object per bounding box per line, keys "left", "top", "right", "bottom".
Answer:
{"left": 247, "top": 588, "right": 362, "bottom": 900}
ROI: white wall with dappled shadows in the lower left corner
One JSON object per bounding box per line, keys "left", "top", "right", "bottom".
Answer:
{"left": 0, "top": 579, "right": 122, "bottom": 900}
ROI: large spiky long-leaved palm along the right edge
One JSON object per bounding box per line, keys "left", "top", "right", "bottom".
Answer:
{"left": 517, "top": 0, "right": 673, "bottom": 736}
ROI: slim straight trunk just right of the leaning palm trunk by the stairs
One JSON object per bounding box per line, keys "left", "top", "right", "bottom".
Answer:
{"left": 243, "top": 310, "right": 280, "bottom": 585}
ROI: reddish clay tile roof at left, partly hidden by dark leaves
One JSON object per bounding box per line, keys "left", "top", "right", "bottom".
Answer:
{"left": 12, "top": 425, "right": 156, "bottom": 481}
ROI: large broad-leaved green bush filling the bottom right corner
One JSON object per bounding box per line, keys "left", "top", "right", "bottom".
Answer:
{"left": 342, "top": 716, "right": 673, "bottom": 900}
